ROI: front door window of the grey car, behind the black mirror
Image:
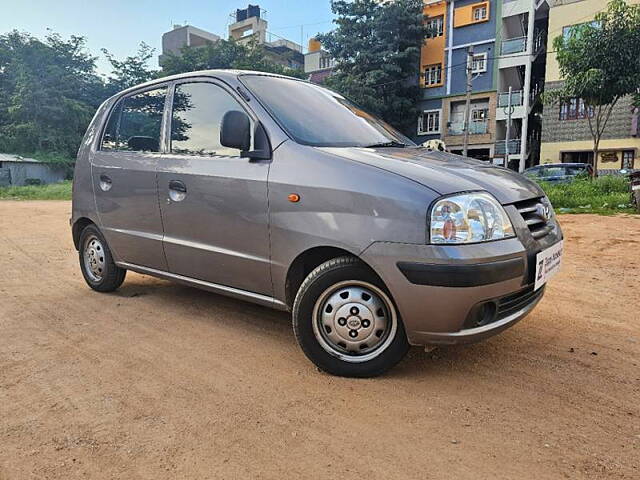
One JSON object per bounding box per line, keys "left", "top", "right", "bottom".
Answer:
{"left": 171, "top": 82, "right": 248, "bottom": 157}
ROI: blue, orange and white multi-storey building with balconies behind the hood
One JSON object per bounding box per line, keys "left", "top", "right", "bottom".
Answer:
{"left": 417, "top": 0, "right": 549, "bottom": 171}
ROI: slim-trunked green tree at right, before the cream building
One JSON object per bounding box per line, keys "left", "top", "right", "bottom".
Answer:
{"left": 547, "top": 0, "right": 640, "bottom": 176}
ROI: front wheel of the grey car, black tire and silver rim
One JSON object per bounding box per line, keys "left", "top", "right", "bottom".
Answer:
{"left": 293, "top": 256, "right": 409, "bottom": 377}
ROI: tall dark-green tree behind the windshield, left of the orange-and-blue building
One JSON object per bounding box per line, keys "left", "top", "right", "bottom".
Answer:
{"left": 318, "top": 0, "right": 427, "bottom": 134}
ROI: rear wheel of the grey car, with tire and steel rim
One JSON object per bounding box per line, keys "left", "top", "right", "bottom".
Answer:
{"left": 78, "top": 225, "right": 127, "bottom": 293}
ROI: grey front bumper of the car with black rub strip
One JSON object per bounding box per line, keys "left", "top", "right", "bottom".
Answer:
{"left": 361, "top": 214, "right": 562, "bottom": 345}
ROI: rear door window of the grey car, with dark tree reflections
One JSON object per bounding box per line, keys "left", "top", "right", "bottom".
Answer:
{"left": 101, "top": 87, "right": 167, "bottom": 152}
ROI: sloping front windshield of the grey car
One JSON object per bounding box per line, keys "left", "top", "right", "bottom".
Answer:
{"left": 241, "top": 75, "right": 415, "bottom": 147}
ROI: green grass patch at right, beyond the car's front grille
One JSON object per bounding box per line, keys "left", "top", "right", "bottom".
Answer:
{"left": 540, "top": 175, "right": 637, "bottom": 215}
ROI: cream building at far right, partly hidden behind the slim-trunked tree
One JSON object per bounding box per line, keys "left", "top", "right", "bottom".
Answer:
{"left": 541, "top": 0, "right": 640, "bottom": 171}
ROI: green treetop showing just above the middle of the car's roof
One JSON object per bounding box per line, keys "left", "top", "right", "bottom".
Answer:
{"left": 162, "top": 40, "right": 304, "bottom": 78}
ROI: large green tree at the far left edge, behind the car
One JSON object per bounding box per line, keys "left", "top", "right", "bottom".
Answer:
{"left": 0, "top": 31, "right": 104, "bottom": 156}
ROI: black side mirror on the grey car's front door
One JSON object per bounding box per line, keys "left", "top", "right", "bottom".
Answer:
{"left": 220, "top": 110, "right": 271, "bottom": 160}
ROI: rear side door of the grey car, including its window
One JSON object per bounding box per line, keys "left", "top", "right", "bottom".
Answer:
{"left": 91, "top": 85, "right": 168, "bottom": 270}
